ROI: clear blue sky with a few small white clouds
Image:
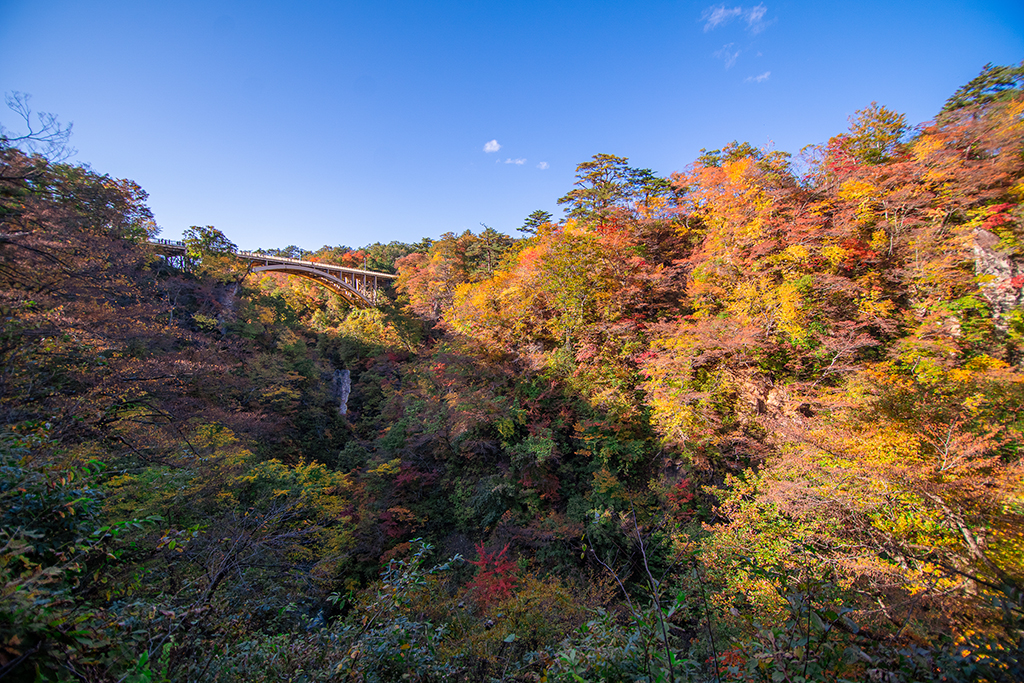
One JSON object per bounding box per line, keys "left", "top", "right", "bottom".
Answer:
{"left": 0, "top": 0, "right": 1024, "bottom": 249}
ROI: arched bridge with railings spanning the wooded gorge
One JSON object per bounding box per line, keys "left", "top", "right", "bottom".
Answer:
{"left": 150, "top": 240, "right": 398, "bottom": 308}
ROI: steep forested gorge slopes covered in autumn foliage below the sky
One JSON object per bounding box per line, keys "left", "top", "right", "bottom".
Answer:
{"left": 0, "top": 63, "right": 1024, "bottom": 681}
